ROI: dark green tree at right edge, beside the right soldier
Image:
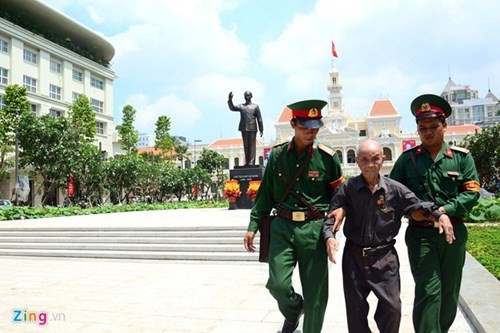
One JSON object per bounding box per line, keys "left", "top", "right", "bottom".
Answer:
{"left": 461, "top": 124, "right": 500, "bottom": 191}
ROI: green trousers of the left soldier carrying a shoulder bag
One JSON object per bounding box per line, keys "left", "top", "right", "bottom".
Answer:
{"left": 266, "top": 217, "right": 328, "bottom": 333}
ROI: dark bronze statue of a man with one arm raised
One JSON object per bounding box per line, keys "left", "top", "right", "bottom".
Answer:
{"left": 227, "top": 91, "right": 264, "bottom": 165}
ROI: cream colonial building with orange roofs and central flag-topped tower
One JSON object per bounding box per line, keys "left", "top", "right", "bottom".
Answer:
{"left": 198, "top": 68, "right": 480, "bottom": 176}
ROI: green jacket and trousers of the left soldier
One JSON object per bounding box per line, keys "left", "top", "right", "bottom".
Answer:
{"left": 248, "top": 98, "right": 343, "bottom": 333}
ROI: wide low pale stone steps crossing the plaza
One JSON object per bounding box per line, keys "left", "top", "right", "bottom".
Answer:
{"left": 0, "top": 227, "right": 259, "bottom": 261}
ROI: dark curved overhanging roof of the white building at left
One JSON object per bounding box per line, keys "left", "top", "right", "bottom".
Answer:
{"left": 0, "top": 0, "right": 115, "bottom": 61}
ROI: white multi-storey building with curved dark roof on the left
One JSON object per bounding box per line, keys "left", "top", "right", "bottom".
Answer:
{"left": 0, "top": 0, "right": 116, "bottom": 201}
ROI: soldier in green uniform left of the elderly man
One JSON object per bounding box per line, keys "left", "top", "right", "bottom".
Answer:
{"left": 244, "top": 100, "right": 343, "bottom": 333}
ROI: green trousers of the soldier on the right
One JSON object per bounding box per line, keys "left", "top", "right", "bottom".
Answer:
{"left": 405, "top": 220, "right": 467, "bottom": 333}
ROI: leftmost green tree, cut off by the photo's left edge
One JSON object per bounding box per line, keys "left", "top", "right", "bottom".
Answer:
{"left": 0, "top": 84, "right": 30, "bottom": 194}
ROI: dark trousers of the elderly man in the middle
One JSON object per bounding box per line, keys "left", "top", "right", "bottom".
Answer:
{"left": 342, "top": 246, "right": 401, "bottom": 333}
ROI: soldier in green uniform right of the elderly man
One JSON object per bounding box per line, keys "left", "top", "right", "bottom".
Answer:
{"left": 390, "top": 95, "right": 480, "bottom": 333}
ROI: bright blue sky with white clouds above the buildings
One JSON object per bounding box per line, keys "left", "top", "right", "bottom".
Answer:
{"left": 44, "top": 0, "right": 500, "bottom": 144}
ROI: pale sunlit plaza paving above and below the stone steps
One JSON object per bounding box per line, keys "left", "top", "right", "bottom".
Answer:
{"left": 0, "top": 209, "right": 475, "bottom": 333}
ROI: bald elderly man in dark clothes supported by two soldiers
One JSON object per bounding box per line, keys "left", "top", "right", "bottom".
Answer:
{"left": 323, "top": 140, "right": 454, "bottom": 333}
